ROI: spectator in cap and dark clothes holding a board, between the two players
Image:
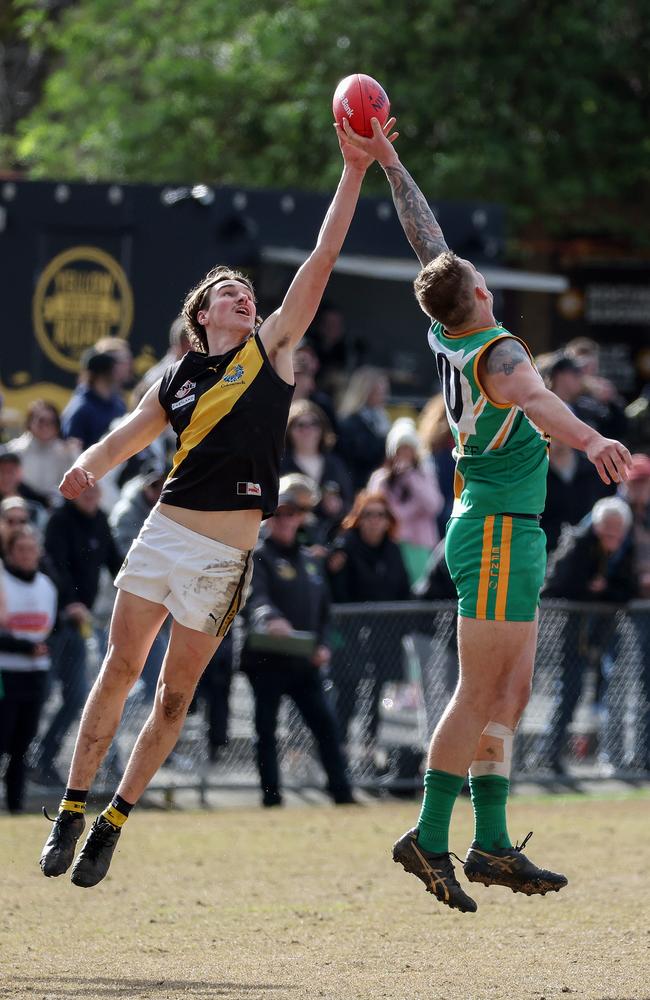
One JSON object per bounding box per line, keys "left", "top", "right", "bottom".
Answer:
{"left": 241, "top": 479, "right": 354, "bottom": 806}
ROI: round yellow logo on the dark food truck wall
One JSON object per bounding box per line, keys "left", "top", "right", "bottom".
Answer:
{"left": 32, "top": 247, "right": 133, "bottom": 372}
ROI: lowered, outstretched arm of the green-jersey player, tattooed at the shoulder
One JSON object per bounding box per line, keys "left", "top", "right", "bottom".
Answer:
{"left": 478, "top": 337, "right": 631, "bottom": 483}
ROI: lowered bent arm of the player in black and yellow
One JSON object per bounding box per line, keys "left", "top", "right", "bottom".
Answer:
{"left": 59, "top": 381, "right": 167, "bottom": 500}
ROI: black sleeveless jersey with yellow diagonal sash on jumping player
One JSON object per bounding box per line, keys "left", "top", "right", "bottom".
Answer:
{"left": 158, "top": 333, "right": 293, "bottom": 517}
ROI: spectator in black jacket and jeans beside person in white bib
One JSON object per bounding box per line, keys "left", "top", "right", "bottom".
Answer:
{"left": 34, "top": 486, "right": 122, "bottom": 785}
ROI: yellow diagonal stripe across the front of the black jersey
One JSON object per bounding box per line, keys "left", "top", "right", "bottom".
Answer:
{"left": 169, "top": 337, "right": 264, "bottom": 479}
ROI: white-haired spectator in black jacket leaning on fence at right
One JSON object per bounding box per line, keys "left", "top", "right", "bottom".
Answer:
{"left": 542, "top": 497, "right": 637, "bottom": 774}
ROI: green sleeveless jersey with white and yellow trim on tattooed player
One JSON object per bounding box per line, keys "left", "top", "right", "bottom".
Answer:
{"left": 429, "top": 323, "right": 548, "bottom": 517}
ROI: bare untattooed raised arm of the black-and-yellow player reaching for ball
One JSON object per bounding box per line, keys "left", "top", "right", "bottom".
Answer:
{"left": 260, "top": 119, "right": 395, "bottom": 377}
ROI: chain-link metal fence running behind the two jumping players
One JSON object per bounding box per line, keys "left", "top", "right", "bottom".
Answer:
{"left": 25, "top": 601, "right": 650, "bottom": 795}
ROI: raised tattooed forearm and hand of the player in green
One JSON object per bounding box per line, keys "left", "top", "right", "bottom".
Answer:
{"left": 343, "top": 118, "right": 449, "bottom": 267}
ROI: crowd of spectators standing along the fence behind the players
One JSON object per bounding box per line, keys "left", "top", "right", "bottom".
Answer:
{"left": 0, "top": 322, "right": 650, "bottom": 812}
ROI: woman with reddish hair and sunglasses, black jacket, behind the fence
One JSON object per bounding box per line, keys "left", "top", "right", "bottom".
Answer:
{"left": 327, "top": 491, "right": 411, "bottom": 759}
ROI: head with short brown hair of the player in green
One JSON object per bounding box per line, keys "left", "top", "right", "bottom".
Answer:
{"left": 413, "top": 250, "right": 474, "bottom": 330}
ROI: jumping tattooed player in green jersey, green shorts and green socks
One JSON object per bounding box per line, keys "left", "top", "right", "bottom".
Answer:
{"left": 344, "top": 119, "right": 630, "bottom": 912}
